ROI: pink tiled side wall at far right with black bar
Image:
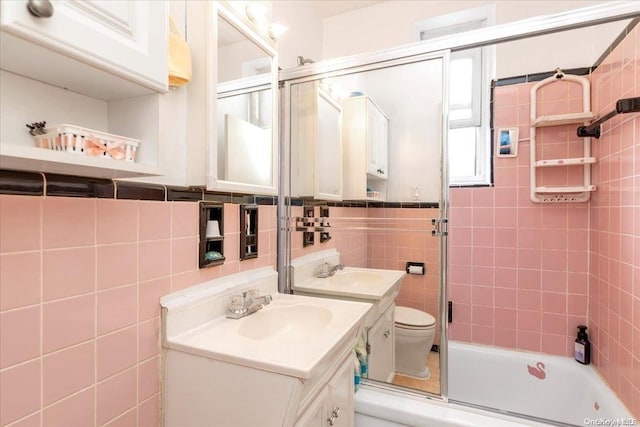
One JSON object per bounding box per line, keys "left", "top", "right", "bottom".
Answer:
{"left": 589, "top": 25, "right": 640, "bottom": 418}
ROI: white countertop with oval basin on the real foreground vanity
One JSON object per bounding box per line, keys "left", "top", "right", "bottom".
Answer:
{"left": 166, "top": 294, "right": 372, "bottom": 378}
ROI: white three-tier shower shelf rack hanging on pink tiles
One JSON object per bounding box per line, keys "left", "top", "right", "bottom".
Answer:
{"left": 529, "top": 69, "right": 596, "bottom": 203}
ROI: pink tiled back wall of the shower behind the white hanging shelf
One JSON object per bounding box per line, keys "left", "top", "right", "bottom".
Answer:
{"left": 449, "top": 77, "right": 589, "bottom": 356}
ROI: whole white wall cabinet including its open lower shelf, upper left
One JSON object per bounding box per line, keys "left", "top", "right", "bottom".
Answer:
{"left": 0, "top": 0, "right": 170, "bottom": 178}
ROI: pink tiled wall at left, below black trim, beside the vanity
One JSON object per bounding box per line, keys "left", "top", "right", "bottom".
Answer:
{"left": 0, "top": 196, "right": 276, "bottom": 427}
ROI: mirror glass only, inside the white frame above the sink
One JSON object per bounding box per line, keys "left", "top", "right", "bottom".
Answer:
{"left": 217, "top": 16, "right": 275, "bottom": 187}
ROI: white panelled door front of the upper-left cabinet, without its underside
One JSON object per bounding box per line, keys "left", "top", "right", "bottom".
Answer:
{"left": 0, "top": 0, "right": 167, "bottom": 91}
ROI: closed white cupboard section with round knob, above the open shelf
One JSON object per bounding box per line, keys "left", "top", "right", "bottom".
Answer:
{"left": 0, "top": 0, "right": 168, "bottom": 101}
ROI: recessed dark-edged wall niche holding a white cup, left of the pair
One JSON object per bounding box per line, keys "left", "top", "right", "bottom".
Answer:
{"left": 198, "top": 202, "right": 225, "bottom": 268}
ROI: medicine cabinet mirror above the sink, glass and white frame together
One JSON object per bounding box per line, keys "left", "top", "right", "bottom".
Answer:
{"left": 208, "top": 3, "right": 278, "bottom": 194}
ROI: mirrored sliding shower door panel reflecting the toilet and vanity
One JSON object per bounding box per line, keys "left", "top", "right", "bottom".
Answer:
{"left": 290, "top": 56, "right": 444, "bottom": 394}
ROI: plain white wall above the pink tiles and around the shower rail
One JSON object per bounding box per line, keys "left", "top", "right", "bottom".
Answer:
{"left": 323, "top": 0, "right": 626, "bottom": 78}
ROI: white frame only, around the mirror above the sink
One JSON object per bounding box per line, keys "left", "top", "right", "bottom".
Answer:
{"left": 206, "top": 1, "right": 280, "bottom": 195}
